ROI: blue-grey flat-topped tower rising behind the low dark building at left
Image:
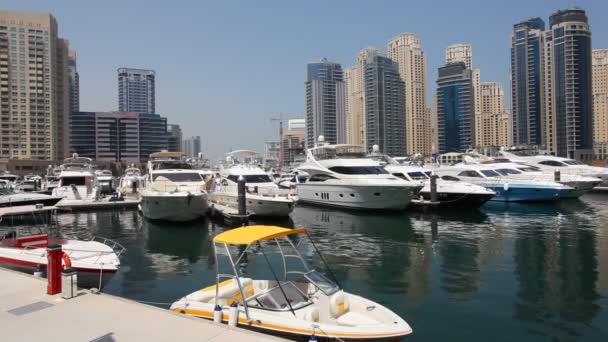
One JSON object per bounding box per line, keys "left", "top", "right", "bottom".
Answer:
{"left": 118, "top": 68, "right": 156, "bottom": 113}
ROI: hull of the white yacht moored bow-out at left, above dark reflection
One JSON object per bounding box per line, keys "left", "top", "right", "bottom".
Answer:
{"left": 141, "top": 191, "right": 209, "bottom": 222}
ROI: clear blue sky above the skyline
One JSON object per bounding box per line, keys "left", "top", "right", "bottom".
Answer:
{"left": 0, "top": 0, "right": 608, "bottom": 158}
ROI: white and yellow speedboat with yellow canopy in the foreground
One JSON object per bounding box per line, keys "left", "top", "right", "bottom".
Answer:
{"left": 170, "top": 226, "right": 412, "bottom": 341}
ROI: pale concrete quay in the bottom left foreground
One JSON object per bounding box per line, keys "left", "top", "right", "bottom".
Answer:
{"left": 0, "top": 268, "right": 283, "bottom": 342}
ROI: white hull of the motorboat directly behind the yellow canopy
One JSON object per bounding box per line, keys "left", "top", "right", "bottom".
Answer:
{"left": 209, "top": 192, "right": 294, "bottom": 217}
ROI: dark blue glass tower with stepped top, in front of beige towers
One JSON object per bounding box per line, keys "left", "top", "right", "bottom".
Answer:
{"left": 436, "top": 62, "right": 475, "bottom": 154}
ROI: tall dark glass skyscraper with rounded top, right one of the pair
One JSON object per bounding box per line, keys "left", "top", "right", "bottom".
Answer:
{"left": 544, "top": 9, "right": 593, "bottom": 160}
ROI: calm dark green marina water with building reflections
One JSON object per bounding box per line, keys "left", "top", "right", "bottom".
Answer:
{"left": 54, "top": 194, "right": 608, "bottom": 342}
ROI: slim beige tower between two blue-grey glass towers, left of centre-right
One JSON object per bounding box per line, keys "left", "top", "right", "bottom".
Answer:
{"left": 345, "top": 48, "right": 379, "bottom": 147}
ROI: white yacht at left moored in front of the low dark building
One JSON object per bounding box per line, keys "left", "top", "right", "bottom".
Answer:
{"left": 52, "top": 153, "right": 98, "bottom": 203}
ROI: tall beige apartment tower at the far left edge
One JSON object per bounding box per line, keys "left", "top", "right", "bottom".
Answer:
{"left": 0, "top": 11, "right": 69, "bottom": 160}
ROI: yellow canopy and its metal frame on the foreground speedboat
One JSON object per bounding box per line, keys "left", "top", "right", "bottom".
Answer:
{"left": 213, "top": 225, "right": 342, "bottom": 321}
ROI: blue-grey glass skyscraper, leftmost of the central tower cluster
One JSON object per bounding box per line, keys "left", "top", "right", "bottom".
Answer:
{"left": 305, "top": 58, "right": 346, "bottom": 148}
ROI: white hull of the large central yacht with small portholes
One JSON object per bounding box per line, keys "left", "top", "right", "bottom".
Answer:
{"left": 297, "top": 183, "right": 414, "bottom": 210}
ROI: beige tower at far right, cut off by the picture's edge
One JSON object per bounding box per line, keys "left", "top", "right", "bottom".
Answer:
{"left": 592, "top": 49, "right": 608, "bottom": 150}
